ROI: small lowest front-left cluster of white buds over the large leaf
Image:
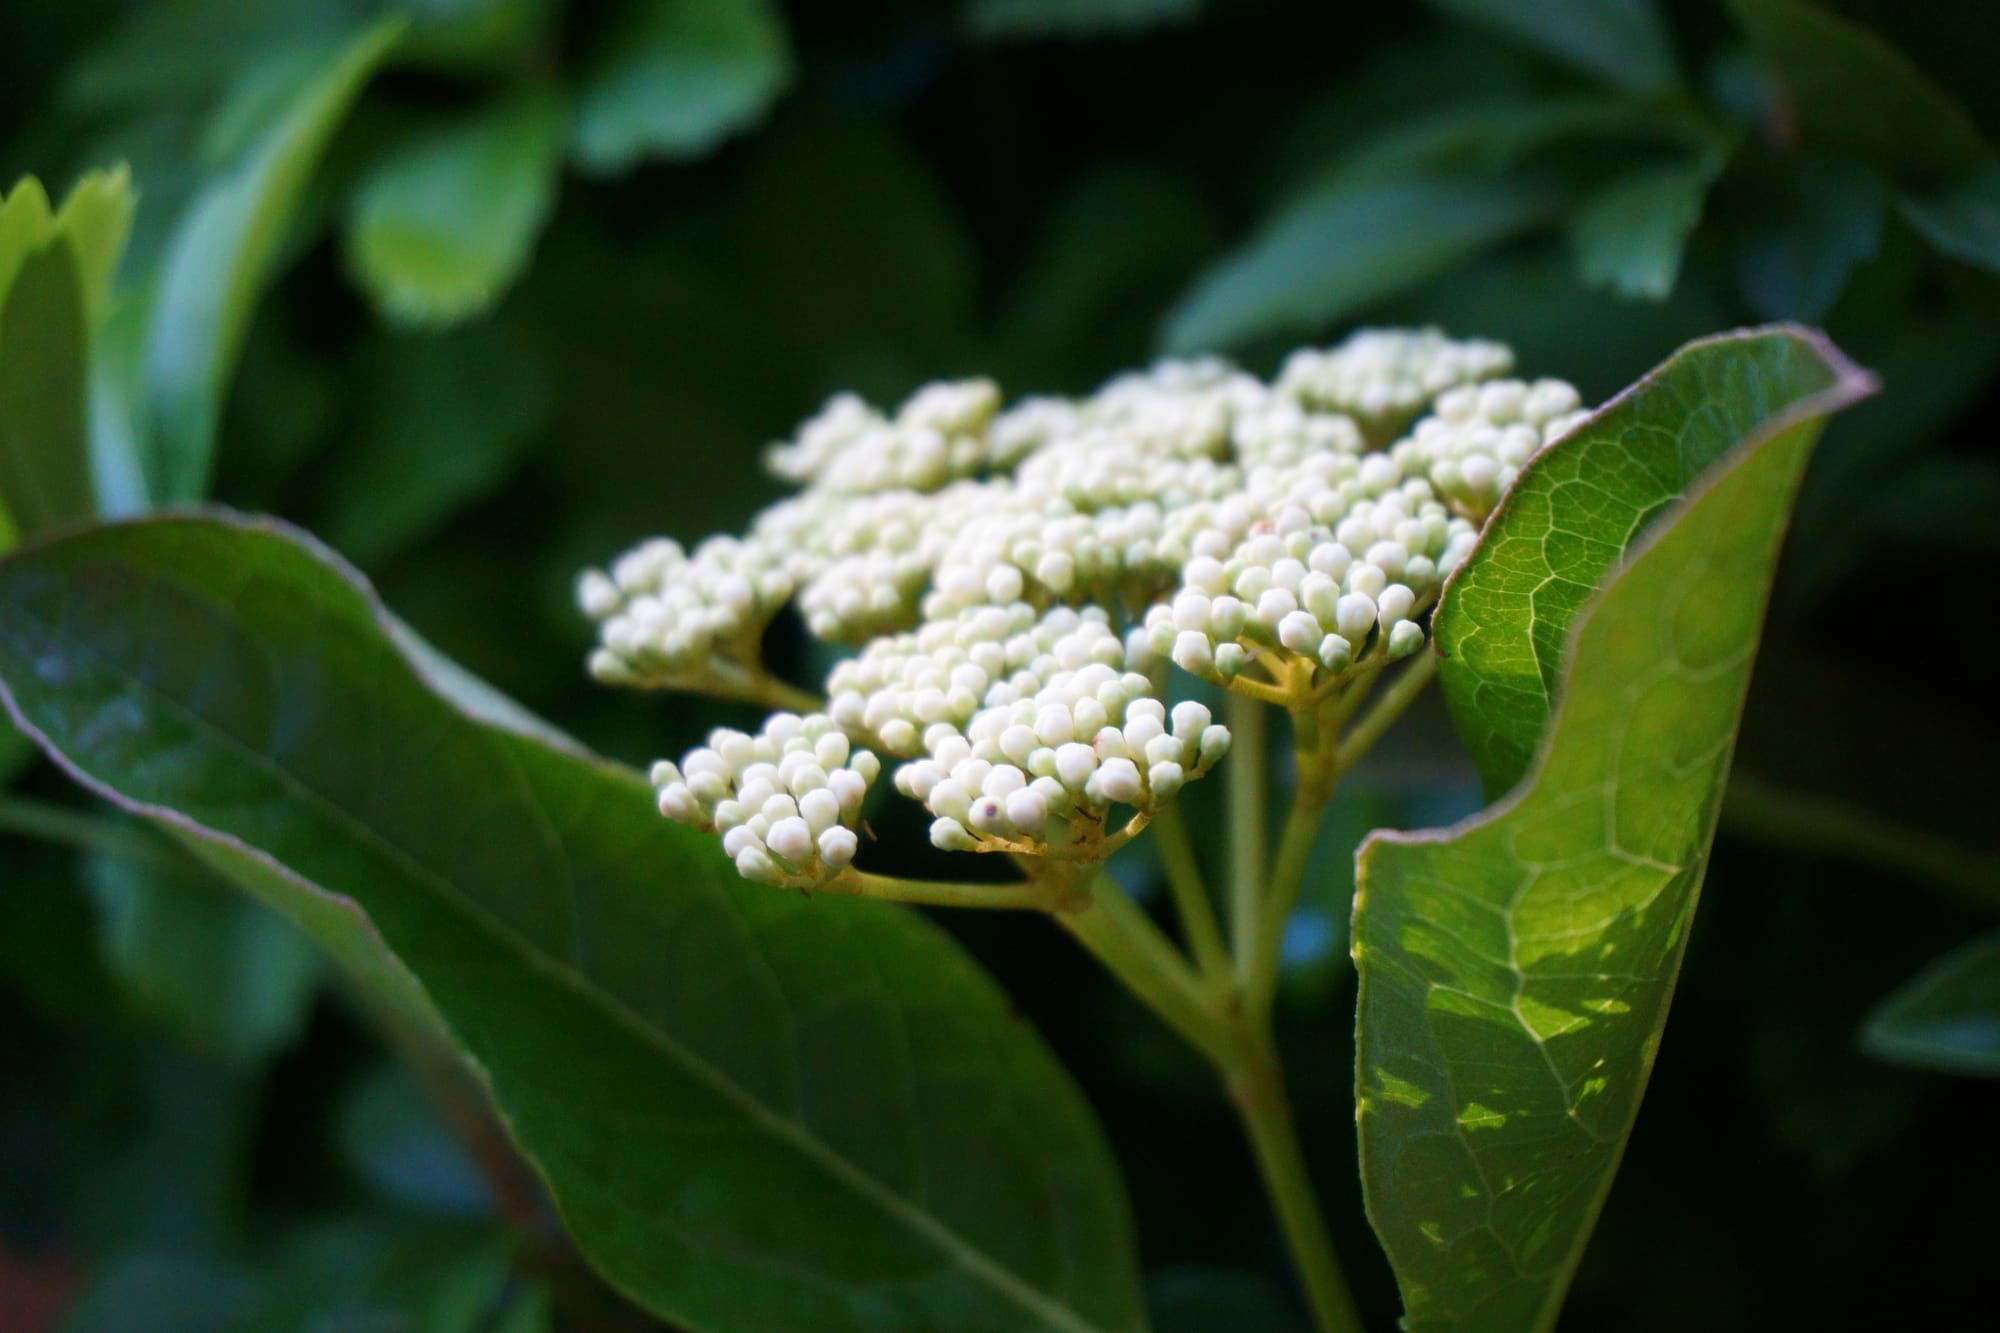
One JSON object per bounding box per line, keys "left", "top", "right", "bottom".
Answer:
{"left": 652, "top": 713, "right": 882, "bottom": 889}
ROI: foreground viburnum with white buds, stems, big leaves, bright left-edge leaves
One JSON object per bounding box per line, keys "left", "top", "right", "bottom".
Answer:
{"left": 0, "top": 176, "right": 1872, "bottom": 1333}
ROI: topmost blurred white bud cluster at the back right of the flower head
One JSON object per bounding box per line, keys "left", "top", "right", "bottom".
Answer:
{"left": 1276, "top": 328, "right": 1514, "bottom": 428}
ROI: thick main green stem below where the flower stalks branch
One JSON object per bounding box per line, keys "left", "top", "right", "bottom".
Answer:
{"left": 1226, "top": 1021, "right": 1362, "bottom": 1333}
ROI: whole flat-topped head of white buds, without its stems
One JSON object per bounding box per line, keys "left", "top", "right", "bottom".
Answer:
{"left": 580, "top": 330, "right": 1578, "bottom": 887}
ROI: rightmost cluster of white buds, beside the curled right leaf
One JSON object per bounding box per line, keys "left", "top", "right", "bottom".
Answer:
{"left": 1390, "top": 380, "right": 1588, "bottom": 520}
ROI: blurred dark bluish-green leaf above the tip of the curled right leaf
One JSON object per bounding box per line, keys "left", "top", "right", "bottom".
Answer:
{"left": 1736, "top": 158, "right": 1888, "bottom": 320}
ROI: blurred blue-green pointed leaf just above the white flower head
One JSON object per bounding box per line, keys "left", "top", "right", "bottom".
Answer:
{"left": 1164, "top": 176, "right": 1554, "bottom": 352}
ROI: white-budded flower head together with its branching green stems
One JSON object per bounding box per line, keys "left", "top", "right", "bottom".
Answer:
{"left": 578, "top": 330, "right": 1856, "bottom": 1329}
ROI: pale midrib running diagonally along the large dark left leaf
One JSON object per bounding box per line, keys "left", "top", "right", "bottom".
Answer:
{"left": 0, "top": 588, "right": 1110, "bottom": 1333}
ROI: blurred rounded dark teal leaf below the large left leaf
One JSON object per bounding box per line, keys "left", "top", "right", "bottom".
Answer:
{"left": 84, "top": 857, "right": 320, "bottom": 1065}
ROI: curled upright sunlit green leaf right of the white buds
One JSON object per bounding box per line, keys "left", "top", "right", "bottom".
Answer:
{"left": 1354, "top": 330, "right": 1870, "bottom": 1333}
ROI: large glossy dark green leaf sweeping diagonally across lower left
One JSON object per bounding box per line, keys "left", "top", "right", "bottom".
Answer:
{"left": 0, "top": 516, "right": 1142, "bottom": 1331}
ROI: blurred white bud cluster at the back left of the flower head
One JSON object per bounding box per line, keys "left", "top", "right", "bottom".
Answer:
{"left": 764, "top": 380, "right": 1016, "bottom": 492}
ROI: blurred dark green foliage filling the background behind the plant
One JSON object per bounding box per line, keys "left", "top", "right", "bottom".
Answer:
{"left": 0, "top": 0, "right": 2000, "bottom": 1333}
